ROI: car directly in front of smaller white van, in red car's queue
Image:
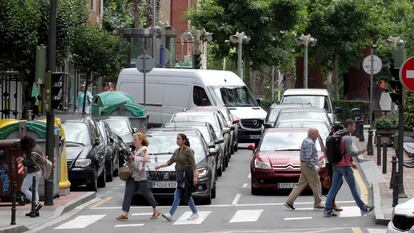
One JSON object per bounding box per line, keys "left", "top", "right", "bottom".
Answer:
{"left": 275, "top": 108, "right": 332, "bottom": 126}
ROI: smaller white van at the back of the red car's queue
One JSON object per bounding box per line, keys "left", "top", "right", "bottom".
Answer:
{"left": 281, "top": 88, "right": 335, "bottom": 123}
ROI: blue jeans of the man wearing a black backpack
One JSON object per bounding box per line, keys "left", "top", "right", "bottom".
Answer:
{"left": 325, "top": 165, "right": 366, "bottom": 211}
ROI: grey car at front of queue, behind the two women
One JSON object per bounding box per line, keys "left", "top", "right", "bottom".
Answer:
{"left": 146, "top": 128, "right": 216, "bottom": 204}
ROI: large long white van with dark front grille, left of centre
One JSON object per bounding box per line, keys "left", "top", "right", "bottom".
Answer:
{"left": 117, "top": 68, "right": 266, "bottom": 142}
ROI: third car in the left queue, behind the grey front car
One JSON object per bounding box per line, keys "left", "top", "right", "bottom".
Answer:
{"left": 171, "top": 112, "right": 230, "bottom": 169}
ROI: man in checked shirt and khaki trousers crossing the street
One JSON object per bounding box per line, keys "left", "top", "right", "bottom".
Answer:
{"left": 284, "top": 128, "right": 324, "bottom": 210}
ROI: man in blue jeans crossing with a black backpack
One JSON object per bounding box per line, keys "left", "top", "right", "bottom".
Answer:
{"left": 324, "top": 119, "right": 374, "bottom": 217}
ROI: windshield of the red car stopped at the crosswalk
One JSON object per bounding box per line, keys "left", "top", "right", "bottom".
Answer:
{"left": 260, "top": 132, "right": 321, "bottom": 151}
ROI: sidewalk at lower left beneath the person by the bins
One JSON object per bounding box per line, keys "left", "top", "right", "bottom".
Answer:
{"left": 0, "top": 192, "right": 96, "bottom": 233}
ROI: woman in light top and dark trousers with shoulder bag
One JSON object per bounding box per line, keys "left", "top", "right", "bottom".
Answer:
{"left": 116, "top": 132, "right": 161, "bottom": 221}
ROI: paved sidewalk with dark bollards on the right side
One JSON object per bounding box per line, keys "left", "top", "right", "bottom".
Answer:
{"left": 354, "top": 130, "right": 414, "bottom": 225}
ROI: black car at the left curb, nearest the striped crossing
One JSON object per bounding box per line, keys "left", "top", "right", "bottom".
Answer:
{"left": 60, "top": 116, "right": 106, "bottom": 191}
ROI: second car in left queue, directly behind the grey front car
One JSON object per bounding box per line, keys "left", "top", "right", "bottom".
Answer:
{"left": 163, "top": 121, "right": 224, "bottom": 176}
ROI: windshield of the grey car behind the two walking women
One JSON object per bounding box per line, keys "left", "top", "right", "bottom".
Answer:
{"left": 147, "top": 134, "right": 205, "bottom": 161}
